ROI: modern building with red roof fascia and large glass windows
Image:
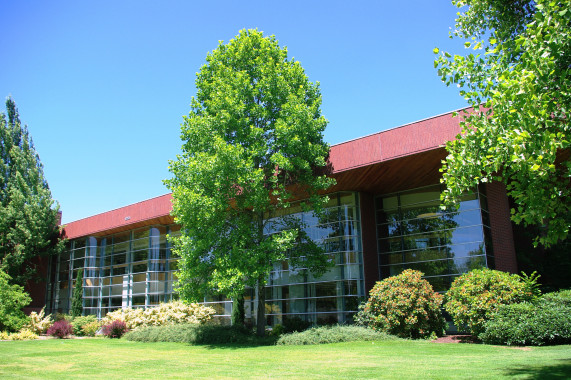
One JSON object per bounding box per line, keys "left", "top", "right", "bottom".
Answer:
{"left": 45, "top": 109, "right": 517, "bottom": 324}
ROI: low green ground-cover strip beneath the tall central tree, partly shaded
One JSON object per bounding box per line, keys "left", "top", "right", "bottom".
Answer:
{"left": 125, "top": 324, "right": 275, "bottom": 345}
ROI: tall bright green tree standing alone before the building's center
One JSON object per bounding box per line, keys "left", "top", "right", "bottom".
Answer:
{"left": 165, "top": 30, "right": 333, "bottom": 335}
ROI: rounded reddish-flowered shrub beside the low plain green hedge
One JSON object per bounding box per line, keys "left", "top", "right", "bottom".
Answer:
{"left": 444, "top": 268, "right": 529, "bottom": 336}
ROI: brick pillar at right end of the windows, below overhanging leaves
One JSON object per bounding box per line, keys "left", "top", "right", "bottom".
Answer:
{"left": 486, "top": 182, "right": 518, "bottom": 273}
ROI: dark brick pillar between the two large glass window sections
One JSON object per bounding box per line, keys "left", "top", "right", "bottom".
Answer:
{"left": 359, "top": 192, "right": 379, "bottom": 298}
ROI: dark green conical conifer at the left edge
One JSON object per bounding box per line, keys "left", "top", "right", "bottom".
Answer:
{"left": 0, "top": 98, "right": 63, "bottom": 285}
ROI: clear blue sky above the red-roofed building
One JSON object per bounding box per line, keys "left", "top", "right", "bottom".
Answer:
{"left": 0, "top": 0, "right": 465, "bottom": 222}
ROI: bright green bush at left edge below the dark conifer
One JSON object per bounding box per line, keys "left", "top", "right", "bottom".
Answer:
{"left": 0, "top": 269, "right": 32, "bottom": 331}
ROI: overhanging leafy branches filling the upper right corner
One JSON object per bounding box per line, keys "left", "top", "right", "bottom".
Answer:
{"left": 435, "top": 0, "right": 571, "bottom": 246}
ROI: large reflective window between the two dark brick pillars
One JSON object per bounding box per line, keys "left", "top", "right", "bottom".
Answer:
{"left": 377, "top": 185, "right": 493, "bottom": 291}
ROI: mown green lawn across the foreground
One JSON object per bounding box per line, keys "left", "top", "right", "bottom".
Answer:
{"left": 0, "top": 338, "right": 571, "bottom": 379}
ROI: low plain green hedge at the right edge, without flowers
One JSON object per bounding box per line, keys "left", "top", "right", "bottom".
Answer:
{"left": 479, "top": 294, "right": 571, "bottom": 346}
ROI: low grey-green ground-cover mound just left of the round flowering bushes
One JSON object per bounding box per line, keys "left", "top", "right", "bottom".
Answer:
{"left": 276, "top": 325, "right": 396, "bottom": 346}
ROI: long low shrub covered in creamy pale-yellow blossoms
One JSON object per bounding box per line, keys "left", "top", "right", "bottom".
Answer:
{"left": 102, "top": 301, "right": 216, "bottom": 330}
